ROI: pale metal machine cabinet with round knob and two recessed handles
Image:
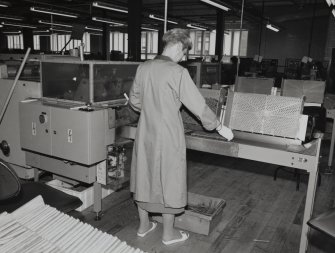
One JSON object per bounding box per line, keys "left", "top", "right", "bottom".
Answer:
{"left": 20, "top": 101, "right": 115, "bottom": 165}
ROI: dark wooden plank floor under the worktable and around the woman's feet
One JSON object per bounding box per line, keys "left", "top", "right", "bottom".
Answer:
{"left": 78, "top": 140, "right": 335, "bottom": 253}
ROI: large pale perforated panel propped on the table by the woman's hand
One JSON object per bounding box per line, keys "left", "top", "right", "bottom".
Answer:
{"left": 224, "top": 92, "right": 303, "bottom": 138}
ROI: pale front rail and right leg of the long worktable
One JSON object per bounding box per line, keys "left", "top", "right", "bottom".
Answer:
{"left": 120, "top": 126, "right": 321, "bottom": 253}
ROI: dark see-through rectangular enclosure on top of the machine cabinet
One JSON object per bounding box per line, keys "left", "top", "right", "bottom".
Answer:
{"left": 41, "top": 60, "right": 139, "bottom": 104}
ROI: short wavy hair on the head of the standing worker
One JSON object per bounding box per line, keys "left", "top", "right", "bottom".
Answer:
{"left": 162, "top": 28, "right": 192, "bottom": 50}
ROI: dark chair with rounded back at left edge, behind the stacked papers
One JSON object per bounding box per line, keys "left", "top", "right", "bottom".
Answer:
{"left": 0, "top": 159, "right": 82, "bottom": 213}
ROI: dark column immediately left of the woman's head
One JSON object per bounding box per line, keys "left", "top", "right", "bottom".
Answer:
{"left": 128, "top": 0, "right": 142, "bottom": 61}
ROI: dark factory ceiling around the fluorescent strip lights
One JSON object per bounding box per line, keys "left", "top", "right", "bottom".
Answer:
{"left": 0, "top": 0, "right": 330, "bottom": 31}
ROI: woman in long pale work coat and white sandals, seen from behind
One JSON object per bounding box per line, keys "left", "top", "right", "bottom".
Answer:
{"left": 129, "top": 29, "right": 233, "bottom": 245}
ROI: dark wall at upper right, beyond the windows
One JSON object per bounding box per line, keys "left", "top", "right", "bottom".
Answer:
{"left": 248, "top": 16, "right": 335, "bottom": 69}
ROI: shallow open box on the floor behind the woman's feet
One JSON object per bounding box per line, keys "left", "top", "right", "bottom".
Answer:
{"left": 152, "top": 192, "right": 226, "bottom": 235}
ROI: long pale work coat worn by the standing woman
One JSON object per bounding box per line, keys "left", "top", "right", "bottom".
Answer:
{"left": 129, "top": 56, "right": 219, "bottom": 208}
